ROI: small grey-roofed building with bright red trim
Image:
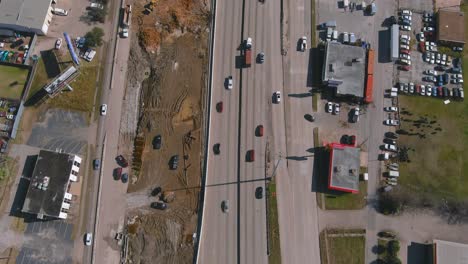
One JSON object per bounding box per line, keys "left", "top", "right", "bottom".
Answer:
{"left": 328, "top": 143, "right": 361, "bottom": 193}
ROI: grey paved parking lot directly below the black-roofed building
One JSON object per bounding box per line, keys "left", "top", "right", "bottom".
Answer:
{"left": 16, "top": 220, "right": 73, "bottom": 264}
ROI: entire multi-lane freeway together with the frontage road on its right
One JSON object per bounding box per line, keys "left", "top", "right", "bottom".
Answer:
{"left": 198, "top": 0, "right": 320, "bottom": 263}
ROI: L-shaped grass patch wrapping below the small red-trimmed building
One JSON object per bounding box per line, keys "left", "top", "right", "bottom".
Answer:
{"left": 324, "top": 181, "right": 367, "bottom": 210}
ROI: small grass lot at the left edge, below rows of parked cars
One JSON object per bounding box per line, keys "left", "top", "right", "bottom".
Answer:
{"left": 0, "top": 65, "right": 29, "bottom": 100}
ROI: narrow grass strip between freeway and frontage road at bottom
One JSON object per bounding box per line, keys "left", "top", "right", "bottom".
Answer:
{"left": 267, "top": 181, "right": 281, "bottom": 264}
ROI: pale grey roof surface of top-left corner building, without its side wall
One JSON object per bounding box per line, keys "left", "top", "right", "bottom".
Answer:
{"left": 0, "top": 0, "right": 52, "bottom": 31}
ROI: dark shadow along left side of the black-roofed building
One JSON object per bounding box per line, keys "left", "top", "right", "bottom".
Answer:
{"left": 10, "top": 155, "right": 38, "bottom": 220}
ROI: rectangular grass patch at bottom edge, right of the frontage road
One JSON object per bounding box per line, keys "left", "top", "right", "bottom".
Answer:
{"left": 320, "top": 230, "right": 366, "bottom": 264}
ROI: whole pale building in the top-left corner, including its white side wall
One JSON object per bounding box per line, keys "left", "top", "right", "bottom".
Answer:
{"left": 0, "top": 0, "right": 52, "bottom": 35}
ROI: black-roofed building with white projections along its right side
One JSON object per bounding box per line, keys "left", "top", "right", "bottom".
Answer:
{"left": 21, "top": 150, "right": 81, "bottom": 219}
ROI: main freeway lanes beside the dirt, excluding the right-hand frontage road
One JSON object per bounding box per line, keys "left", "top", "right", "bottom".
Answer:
{"left": 198, "top": 0, "right": 282, "bottom": 263}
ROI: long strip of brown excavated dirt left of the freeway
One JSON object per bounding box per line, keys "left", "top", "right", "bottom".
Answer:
{"left": 120, "top": 0, "right": 209, "bottom": 263}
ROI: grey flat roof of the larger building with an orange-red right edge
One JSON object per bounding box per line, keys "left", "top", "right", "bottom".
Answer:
{"left": 323, "top": 42, "right": 366, "bottom": 98}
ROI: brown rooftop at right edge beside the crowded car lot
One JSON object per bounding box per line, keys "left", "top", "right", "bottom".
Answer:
{"left": 437, "top": 10, "right": 465, "bottom": 43}
